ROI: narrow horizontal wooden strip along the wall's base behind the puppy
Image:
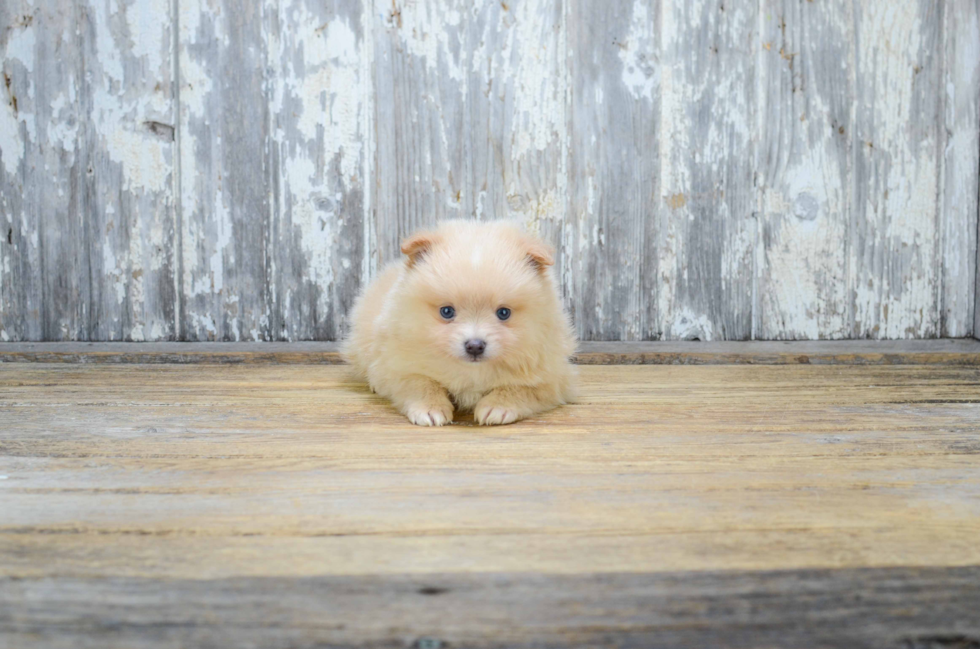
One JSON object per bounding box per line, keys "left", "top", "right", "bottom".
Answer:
{"left": 0, "top": 339, "right": 980, "bottom": 366}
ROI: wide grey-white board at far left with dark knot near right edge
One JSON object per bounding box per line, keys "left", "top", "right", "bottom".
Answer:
{"left": 0, "top": 0, "right": 174, "bottom": 340}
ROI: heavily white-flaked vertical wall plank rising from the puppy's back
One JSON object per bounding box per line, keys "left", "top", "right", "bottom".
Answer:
{"left": 270, "top": 0, "right": 373, "bottom": 340}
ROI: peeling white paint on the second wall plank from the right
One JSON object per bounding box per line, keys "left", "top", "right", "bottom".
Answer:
{"left": 852, "top": 0, "right": 939, "bottom": 338}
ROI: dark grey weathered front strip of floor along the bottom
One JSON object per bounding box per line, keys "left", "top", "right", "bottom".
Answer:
{"left": 0, "top": 567, "right": 980, "bottom": 649}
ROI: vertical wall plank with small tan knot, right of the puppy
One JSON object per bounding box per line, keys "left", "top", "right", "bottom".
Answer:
{"left": 658, "top": 0, "right": 759, "bottom": 340}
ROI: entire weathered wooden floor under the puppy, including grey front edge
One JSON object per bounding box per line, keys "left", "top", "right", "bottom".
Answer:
{"left": 0, "top": 352, "right": 980, "bottom": 649}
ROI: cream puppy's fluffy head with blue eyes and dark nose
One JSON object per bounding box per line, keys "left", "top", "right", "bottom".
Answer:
{"left": 392, "top": 221, "right": 563, "bottom": 367}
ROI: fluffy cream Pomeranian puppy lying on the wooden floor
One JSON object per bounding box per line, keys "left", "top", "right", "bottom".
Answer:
{"left": 344, "top": 221, "right": 575, "bottom": 426}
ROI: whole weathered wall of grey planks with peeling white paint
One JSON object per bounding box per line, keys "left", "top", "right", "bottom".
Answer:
{"left": 0, "top": 0, "right": 980, "bottom": 340}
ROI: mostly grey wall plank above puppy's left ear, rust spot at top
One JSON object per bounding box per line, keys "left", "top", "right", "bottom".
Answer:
{"left": 373, "top": 0, "right": 473, "bottom": 266}
